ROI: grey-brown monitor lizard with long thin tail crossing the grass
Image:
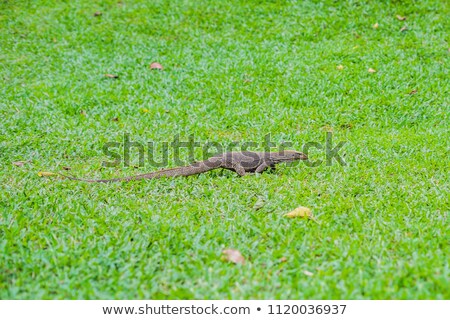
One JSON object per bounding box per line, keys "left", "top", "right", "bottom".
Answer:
{"left": 62, "top": 150, "right": 308, "bottom": 183}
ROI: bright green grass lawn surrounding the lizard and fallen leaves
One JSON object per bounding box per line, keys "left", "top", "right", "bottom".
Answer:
{"left": 0, "top": 0, "right": 450, "bottom": 299}
